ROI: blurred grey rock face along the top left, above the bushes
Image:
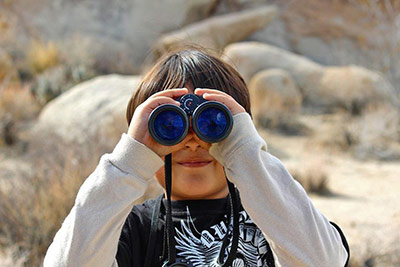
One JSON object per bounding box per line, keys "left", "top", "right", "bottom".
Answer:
{"left": 0, "top": 0, "right": 216, "bottom": 73}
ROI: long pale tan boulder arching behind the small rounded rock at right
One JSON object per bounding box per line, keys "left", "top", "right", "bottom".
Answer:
{"left": 224, "top": 42, "right": 398, "bottom": 114}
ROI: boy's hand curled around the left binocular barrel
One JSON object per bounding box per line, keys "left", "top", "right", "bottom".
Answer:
{"left": 127, "top": 88, "right": 188, "bottom": 157}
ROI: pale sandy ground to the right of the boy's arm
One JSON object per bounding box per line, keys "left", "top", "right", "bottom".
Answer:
{"left": 259, "top": 114, "right": 400, "bottom": 266}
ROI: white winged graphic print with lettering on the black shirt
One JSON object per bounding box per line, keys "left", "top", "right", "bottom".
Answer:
{"left": 175, "top": 211, "right": 269, "bottom": 267}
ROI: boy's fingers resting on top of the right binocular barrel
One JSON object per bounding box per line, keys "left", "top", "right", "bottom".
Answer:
{"left": 194, "top": 88, "right": 246, "bottom": 116}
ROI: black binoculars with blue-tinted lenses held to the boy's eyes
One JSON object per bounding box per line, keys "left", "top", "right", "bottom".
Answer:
{"left": 148, "top": 94, "right": 233, "bottom": 146}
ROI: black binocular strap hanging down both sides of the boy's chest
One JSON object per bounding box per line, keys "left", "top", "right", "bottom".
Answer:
{"left": 153, "top": 154, "right": 240, "bottom": 267}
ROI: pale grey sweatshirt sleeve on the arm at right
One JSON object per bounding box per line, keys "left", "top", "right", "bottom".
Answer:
{"left": 210, "top": 113, "right": 347, "bottom": 267}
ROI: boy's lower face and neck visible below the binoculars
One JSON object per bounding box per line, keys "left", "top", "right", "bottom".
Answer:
{"left": 155, "top": 129, "right": 229, "bottom": 200}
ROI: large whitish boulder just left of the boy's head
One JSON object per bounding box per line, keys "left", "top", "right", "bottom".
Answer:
{"left": 34, "top": 75, "right": 140, "bottom": 145}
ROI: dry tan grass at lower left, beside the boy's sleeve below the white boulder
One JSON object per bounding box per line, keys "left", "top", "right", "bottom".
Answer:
{"left": 0, "top": 130, "right": 111, "bottom": 266}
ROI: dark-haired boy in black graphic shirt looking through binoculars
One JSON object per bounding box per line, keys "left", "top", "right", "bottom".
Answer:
{"left": 44, "top": 49, "right": 349, "bottom": 266}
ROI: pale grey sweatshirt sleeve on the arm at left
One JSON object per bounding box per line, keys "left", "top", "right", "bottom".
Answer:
{"left": 44, "top": 133, "right": 164, "bottom": 267}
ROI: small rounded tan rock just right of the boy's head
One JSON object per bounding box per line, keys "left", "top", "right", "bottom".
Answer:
{"left": 249, "top": 69, "right": 302, "bottom": 118}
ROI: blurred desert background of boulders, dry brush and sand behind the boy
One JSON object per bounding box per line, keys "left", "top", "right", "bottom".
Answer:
{"left": 0, "top": 0, "right": 400, "bottom": 267}
